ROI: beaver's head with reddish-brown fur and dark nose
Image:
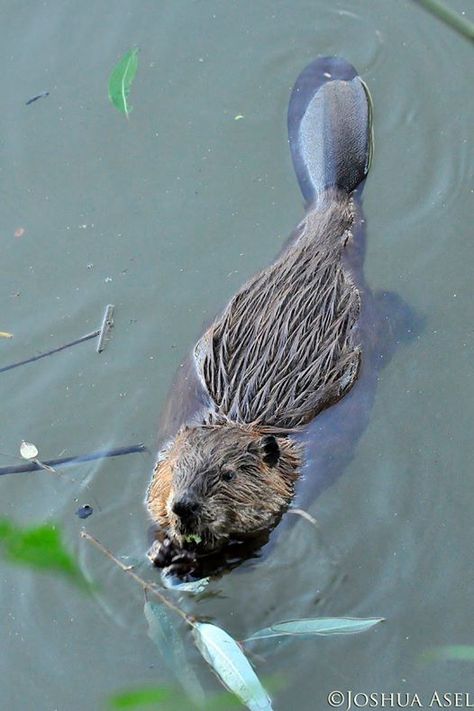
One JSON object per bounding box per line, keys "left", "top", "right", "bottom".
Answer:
{"left": 147, "top": 424, "right": 299, "bottom": 551}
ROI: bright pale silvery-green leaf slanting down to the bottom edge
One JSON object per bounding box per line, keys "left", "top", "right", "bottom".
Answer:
{"left": 193, "top": 622, "right": 272, "bottom": 711}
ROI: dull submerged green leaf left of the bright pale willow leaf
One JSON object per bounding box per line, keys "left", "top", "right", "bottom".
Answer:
{"left": 144, "top": 600, "right": 204, "bottom": 705}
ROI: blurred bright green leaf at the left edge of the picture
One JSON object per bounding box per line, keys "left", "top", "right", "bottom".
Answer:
{"left": 0, "top": 519, "right": 90, "bottom": 587}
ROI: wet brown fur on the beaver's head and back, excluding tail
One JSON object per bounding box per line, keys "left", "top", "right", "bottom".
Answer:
{"left": 147, "top": 192, "right": 361, "bottom": 549}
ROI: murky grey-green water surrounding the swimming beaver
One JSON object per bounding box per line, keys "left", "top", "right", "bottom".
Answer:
{"left": 0, "top": 0, "right": 474, "bottom": 711}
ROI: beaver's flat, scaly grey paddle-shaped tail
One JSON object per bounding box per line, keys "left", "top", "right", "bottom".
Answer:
{"left": 288, "top": 57, "right": 372, "bottom": 203}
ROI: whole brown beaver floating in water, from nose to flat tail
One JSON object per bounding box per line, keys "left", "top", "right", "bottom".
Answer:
{"left": 146, "top": 57, "right": 372, "bottom": 580}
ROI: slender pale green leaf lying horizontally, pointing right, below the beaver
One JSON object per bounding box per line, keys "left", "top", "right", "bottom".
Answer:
{"left": 244, "top": 617, "right": 384, "bottom": 642}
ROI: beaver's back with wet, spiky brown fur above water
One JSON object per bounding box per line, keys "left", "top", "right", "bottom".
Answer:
{"left": 195, "top": 192, "right": 360, "bottom": 428}
